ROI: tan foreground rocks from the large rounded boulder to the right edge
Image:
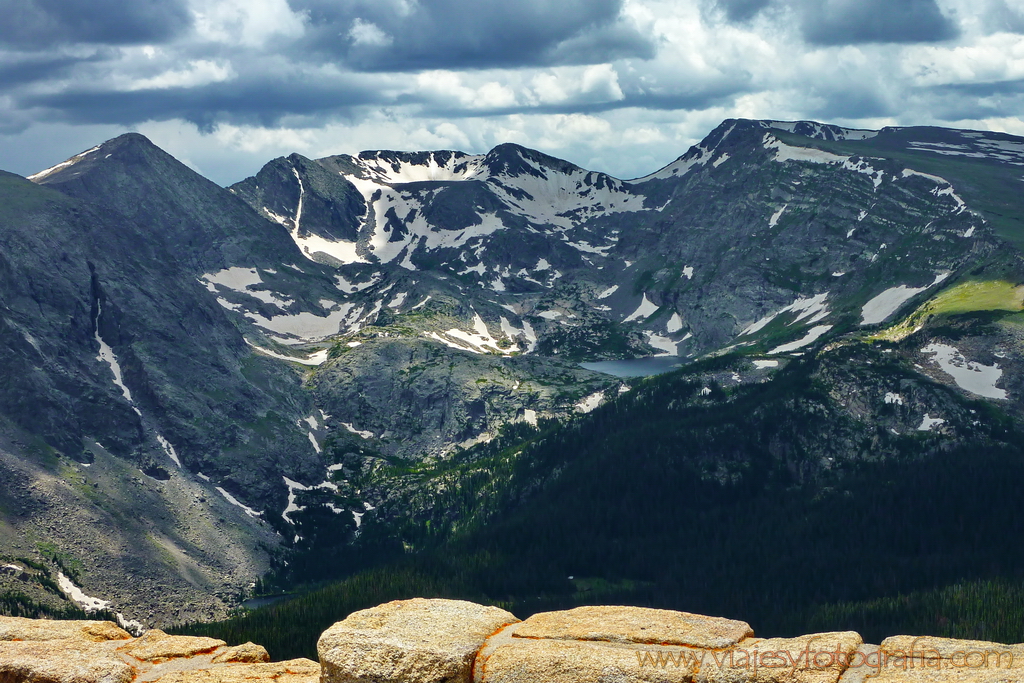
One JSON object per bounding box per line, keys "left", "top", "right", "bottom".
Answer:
{"left": 318, "top": 599, "right": 1024, "bottom": 683}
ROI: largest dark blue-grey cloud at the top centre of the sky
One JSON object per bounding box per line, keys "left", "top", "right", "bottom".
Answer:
{"left": 291, "top": 0, "right": 655, "bottom": 71}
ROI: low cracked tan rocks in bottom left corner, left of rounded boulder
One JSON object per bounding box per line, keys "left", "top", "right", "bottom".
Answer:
{"left": 0, "top": 616, "right": 321, "bottom": 683}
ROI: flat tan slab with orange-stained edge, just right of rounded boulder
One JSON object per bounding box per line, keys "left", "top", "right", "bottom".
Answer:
{"left": 513, "top": 606, "right": 754, "bottom": 649}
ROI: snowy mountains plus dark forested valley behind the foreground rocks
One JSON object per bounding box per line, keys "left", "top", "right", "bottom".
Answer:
{"left": 0, "top": 114, "right": 1024, "bottom": 643}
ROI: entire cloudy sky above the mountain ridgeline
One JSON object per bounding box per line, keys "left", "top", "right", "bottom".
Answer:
{"left": 0, "top": 0, "right": 1024, "bottom": 184}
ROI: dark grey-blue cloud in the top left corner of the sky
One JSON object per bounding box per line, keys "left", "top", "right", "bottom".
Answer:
{"left": 0, "top": 0, "right": 190, "bottom": 48}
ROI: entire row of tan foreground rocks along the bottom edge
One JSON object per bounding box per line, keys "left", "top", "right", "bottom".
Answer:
{"left": 0, "top": 598, "right": 1024, "bottom": 683}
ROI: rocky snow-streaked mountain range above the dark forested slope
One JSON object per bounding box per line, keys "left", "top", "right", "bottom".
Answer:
{"left": 0, "top": 121, "right": 1024, "bottom": 624}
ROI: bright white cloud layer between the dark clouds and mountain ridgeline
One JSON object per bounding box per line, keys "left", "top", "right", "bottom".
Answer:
{"left": 0, "top": 0, "right": 1024, "bottom": 183}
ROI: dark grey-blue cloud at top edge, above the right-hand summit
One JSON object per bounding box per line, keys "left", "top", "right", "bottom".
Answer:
{"left": 715, "top": 0, "right": 958, "bottom": 45}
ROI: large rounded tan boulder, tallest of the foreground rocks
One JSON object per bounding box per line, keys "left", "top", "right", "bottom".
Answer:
{"left": 316, "top": 598, "right": 519, "bottom": 683}
